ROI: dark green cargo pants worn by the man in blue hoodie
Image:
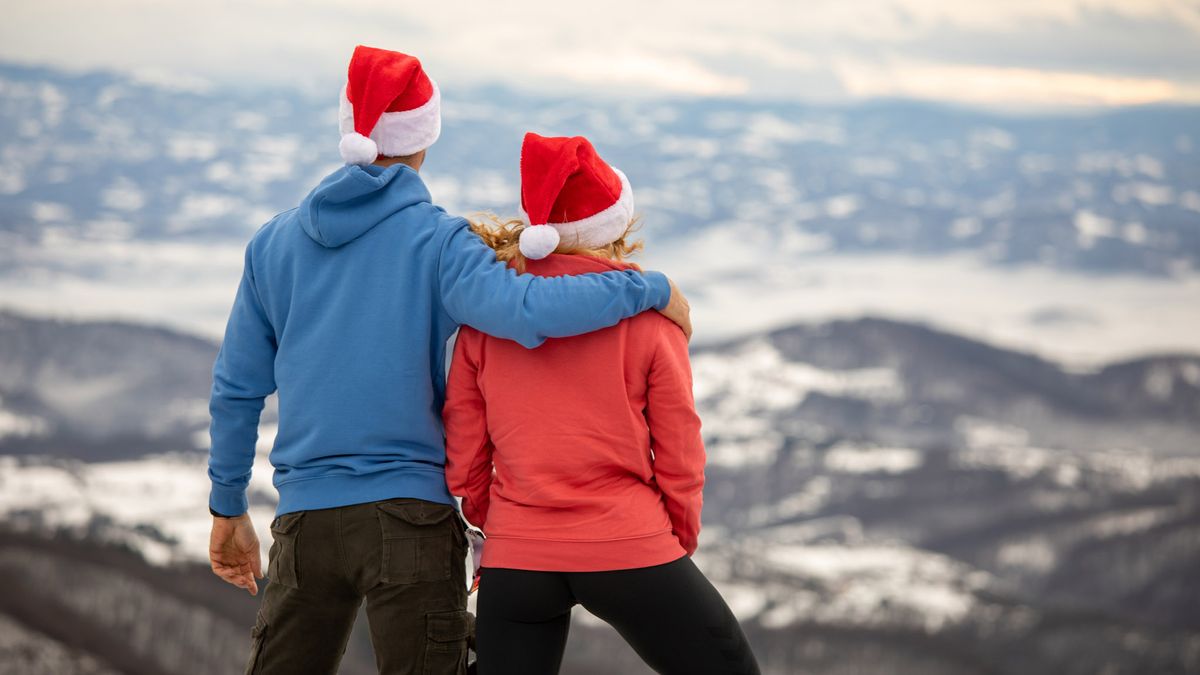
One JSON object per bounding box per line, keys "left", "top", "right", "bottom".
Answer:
{"left": 246, "top": 498, "right": 474, "bottom": 675}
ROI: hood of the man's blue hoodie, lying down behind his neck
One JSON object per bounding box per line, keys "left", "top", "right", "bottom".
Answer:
{"left": 299, "top": 165, "right": 431, "bottom": 249}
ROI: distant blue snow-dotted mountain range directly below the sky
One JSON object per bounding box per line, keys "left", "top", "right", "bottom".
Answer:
{"left": 0, "top": 64, "right": 1200, "bottom": 275}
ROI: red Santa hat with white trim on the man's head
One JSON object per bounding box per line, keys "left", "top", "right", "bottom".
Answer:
{"left": 338, "top": 44, "right": 442, "bottom": 165}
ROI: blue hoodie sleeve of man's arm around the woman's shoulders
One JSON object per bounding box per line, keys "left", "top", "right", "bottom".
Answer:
{"left": 438, "top": 219, "right": 671, "bottom": 348}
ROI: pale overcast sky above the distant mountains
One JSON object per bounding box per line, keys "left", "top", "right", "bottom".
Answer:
{"left": 0, "top": 0, "right": 1200, "bottom": 109}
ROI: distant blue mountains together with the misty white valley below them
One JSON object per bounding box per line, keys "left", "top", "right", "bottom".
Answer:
{"left": 7, "top": 65, "right": 1200, "bottom": 366}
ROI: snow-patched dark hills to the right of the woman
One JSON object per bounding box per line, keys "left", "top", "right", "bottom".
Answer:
{"left": 694, "top": 319, "right": 1200, "bottom": 673}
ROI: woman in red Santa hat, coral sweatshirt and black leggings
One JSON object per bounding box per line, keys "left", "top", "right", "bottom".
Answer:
{"left": 444, "top": 133, "right": 758, "bottom": 675}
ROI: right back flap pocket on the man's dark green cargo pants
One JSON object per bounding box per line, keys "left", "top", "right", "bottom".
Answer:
{"left": 378, "top": 502, "right": 458, "bottom": 584}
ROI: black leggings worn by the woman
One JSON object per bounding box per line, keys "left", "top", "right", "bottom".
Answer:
{"left": 476, "top": 557, "right": 758, "bottom": 675}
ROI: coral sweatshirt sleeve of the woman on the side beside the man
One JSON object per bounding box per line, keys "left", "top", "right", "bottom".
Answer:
{"left": 442, "top": 328, "right": 494, "bottom": 528}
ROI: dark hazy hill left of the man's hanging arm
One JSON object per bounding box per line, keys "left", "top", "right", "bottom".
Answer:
{"left": 0, "top": 310, "right": 217, "bottom": 460}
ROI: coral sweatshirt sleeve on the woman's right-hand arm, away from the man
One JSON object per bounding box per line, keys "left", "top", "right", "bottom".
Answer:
{"left": 646, "top": 314, "right": 704, "bottom": 555}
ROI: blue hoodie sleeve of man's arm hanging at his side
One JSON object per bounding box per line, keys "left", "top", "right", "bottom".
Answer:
{"left": 209, "top": 247, "right": 276, "bottom": 515}
